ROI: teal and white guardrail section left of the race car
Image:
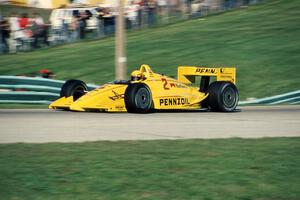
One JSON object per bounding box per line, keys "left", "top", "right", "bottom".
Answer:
{"left": 0, "top": 76, "right": 98, "bottom": 104}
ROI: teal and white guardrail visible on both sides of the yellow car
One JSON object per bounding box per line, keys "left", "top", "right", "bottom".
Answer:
{"left": 0, "top": 76, "right": 300, "bottom": 105}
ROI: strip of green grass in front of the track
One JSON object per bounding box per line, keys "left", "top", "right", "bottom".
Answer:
{"left": 0, "top": 138, "right": 300, "bottom": 200}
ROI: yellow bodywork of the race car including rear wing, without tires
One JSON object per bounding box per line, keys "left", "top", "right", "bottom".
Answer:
{"left": 49, "top": 65, "right": 236, "bottom": 112}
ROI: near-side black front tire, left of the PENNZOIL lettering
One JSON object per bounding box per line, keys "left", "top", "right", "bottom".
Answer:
{"left": 124, "top": 83, "right": 153, "bottom": 113}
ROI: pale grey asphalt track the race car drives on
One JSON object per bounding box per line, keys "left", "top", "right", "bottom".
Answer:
{"left": 0, "top": 105, "right": 300, "bottom": 143}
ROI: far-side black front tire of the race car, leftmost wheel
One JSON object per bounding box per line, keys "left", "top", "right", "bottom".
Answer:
{"left": 60, "top": 80, "right": 88, "bottom": 101}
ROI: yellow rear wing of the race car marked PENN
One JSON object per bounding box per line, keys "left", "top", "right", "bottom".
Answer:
{"left": 177, "top": 66, "right": 236, "bottom": 84}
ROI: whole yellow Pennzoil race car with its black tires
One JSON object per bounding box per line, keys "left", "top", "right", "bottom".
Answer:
{"left": 49, "top": 65, "right": 239, "bottom": 113}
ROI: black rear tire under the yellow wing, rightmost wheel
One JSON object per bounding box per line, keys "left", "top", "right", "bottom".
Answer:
{"left": 207, "top": 81, "right": 239, "bottom": 112}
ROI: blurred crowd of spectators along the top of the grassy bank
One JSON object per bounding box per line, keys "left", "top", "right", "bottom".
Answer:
{"left": 0, "top": 0, "right": 259, "bottom": 54}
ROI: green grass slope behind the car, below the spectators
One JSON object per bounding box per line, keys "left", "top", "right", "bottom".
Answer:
{"left": 0, "top": 0, "right": 300, "bottom": 100}
